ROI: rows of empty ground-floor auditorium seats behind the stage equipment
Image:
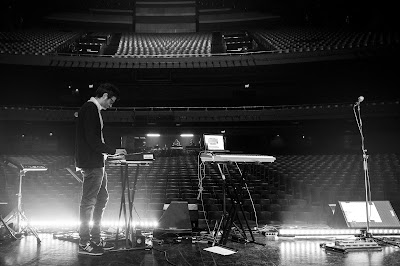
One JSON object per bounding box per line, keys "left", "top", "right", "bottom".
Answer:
{"left": 1, "top": 153, "right": 400, "bottom": 230}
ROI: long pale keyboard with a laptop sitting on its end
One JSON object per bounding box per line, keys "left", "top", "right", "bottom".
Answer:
{"left": 200, "top": 153, "right": 276, "bottom": 163}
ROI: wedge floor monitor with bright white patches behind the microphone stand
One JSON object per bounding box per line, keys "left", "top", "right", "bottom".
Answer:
{"left": 328, "top": 201, "right": 400, "bottom": 229}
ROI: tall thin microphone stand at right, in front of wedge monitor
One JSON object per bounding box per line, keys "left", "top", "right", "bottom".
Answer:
{"left": 353, "top": 102, "right": 372, "bottom": 238}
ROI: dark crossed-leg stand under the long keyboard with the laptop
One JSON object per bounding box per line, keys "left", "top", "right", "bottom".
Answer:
{"left": 218, "top": 163, "right": 265, "bottom": 246}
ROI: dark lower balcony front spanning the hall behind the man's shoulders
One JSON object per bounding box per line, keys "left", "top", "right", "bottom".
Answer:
{"left": 0, "top": 100, "right": 400, "bottom": 124}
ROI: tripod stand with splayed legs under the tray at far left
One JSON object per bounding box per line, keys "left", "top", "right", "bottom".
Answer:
{"left": 2, "top": 169, "right": 41, "bottom": 244}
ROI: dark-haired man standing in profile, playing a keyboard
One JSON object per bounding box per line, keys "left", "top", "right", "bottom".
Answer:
{"left": 75, "top": 83, "right": 126, "bottom": 255}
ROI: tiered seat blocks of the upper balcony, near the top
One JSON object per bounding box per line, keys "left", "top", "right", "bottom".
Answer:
{"left": 0, "top": 27, "right": 400, "bottom": 57}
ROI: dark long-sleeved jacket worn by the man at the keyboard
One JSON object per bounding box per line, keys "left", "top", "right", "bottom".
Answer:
{"left": 75, "top": 102, "right": 115, "bottom": 168}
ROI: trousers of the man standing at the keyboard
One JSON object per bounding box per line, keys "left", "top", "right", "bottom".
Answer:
{"left": 79, "top": 167, "right": 108, "bottom": 244}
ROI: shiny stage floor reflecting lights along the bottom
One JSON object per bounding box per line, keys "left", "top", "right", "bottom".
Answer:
{"left": 0, "top": 233, "right": 400, "bottom": 266}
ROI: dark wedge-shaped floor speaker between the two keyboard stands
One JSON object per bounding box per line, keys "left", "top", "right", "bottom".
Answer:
{"left": 153, "top": 201, "right": 192, "bottom": 239}
